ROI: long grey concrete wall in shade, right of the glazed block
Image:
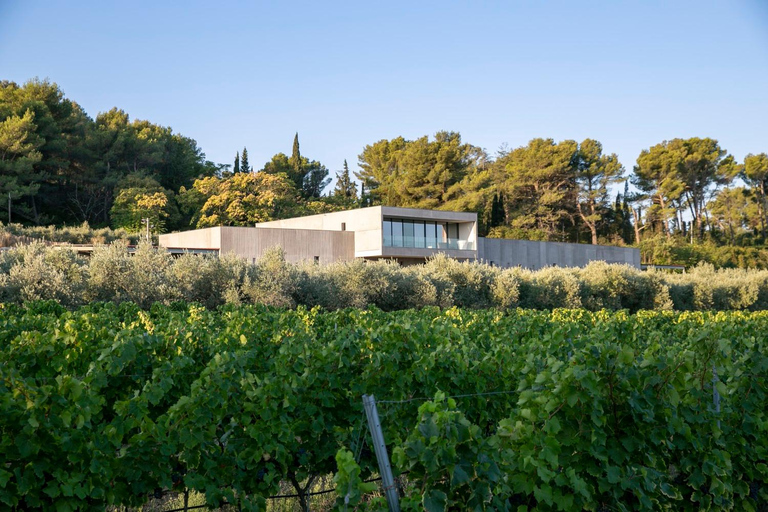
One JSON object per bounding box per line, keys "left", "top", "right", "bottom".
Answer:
{"left": 477, "top": 238, "right": 640, "bottom": 270}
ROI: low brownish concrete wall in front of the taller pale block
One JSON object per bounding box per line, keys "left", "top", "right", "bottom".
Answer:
{"left": 221, "top": 227, "right": 355, "bottom": 265}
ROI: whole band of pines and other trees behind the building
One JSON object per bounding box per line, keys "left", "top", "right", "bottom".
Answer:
{"left": 0, "top": 80, "right": 768, "bottom": 268}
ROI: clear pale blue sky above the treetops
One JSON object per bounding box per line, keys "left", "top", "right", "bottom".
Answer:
{"left": 0, "top": 0, "right": 768, "bottom": 184}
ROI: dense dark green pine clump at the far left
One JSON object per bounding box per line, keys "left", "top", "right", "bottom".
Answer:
{"left": 0, "top": 80, "right": 220, "bottom": 227}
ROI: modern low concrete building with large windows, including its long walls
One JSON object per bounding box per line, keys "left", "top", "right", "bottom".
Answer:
{"left": 160, "top": 206, "right": 640, "bottom": 269}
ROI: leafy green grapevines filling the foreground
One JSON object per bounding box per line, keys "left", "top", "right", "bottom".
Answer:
{"left": 0, "top": 302, "right": 768, "bottom": 512}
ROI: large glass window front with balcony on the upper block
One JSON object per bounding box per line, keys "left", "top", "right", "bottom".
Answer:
{"left": 382, "top": 218, "right": 474, "bottom": 250}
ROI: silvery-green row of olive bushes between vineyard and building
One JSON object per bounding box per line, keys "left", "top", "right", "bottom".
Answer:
{"left": 0, "top": 242, "right": 768, "bottom": 312}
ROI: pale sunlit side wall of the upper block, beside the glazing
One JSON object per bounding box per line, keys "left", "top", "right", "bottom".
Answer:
{"left": 256, "top": 206, "right": 384, "bottom": 258}
